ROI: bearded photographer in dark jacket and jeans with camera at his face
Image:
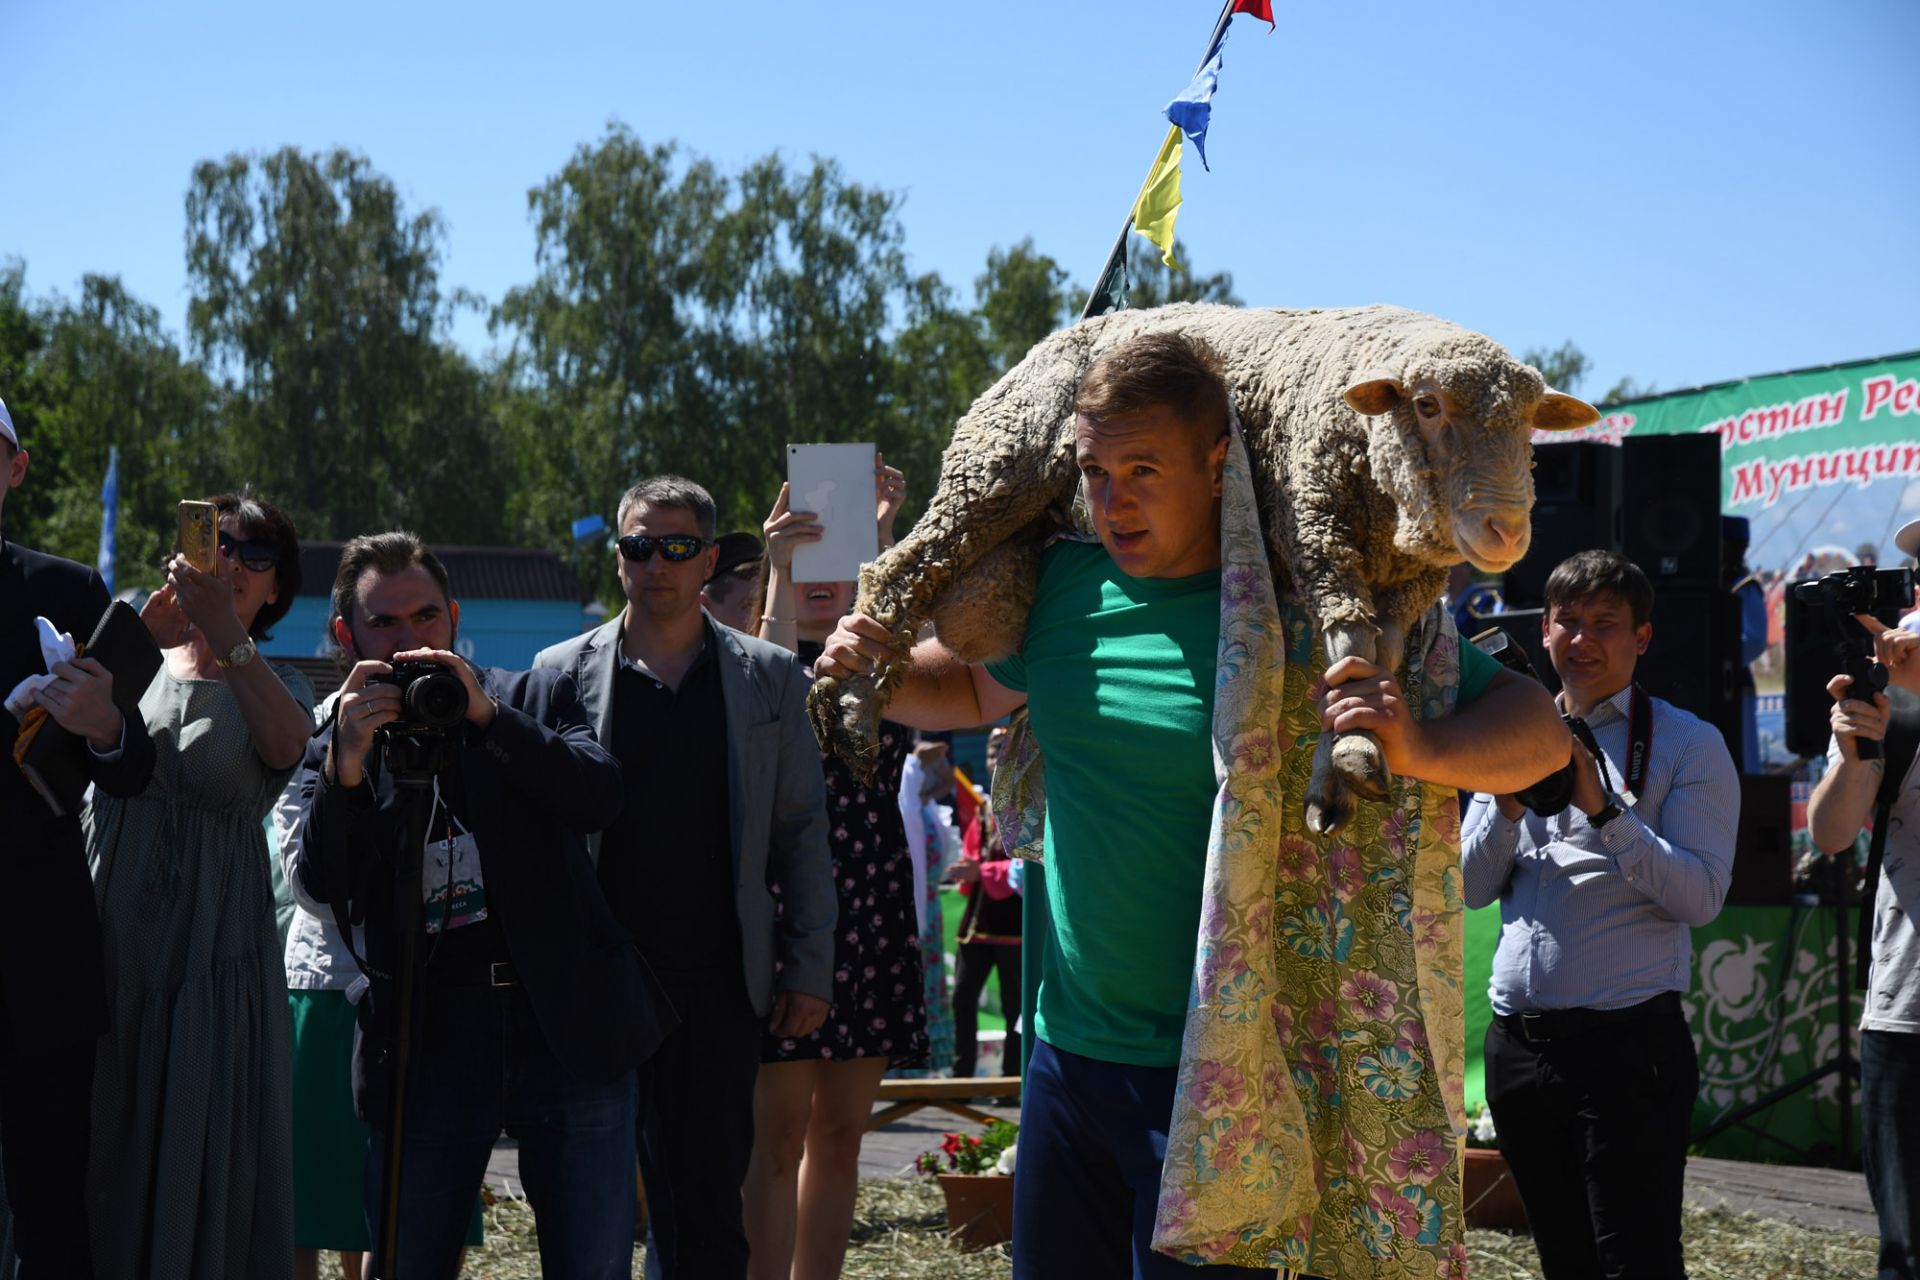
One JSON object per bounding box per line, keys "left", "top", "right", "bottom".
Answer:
{"left": 292, "top": 533, "right": 672, "bottom": 1280}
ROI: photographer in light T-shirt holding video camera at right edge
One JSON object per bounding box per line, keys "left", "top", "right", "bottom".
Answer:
{"left": 1807, "top": 520, "right": 1920, "bottom": 1280}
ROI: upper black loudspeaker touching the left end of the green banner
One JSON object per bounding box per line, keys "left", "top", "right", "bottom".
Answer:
{"left": 1620, "top": 432, "right": 1722, "bottom": 591}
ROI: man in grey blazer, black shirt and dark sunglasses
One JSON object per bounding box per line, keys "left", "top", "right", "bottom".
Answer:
{"left": 536, "top": 476, "right": 837, "bottom": 1280}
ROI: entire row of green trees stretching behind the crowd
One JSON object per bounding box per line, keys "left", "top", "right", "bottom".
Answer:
{"left": 0, "top": 125, "right": 1236, "bottom": 610}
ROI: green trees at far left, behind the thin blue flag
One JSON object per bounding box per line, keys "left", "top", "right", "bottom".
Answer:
{"left": 0, "top": 263, "right": 230, "bottom": 587}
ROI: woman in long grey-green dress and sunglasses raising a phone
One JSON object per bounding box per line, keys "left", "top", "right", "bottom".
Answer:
{"left": 84, "top": 493, "right": 313, "bottom": 1280}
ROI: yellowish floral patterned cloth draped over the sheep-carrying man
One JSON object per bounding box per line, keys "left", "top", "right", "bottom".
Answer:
{"left": 995, "top": 426, "right": 1467, "bottom": 1280}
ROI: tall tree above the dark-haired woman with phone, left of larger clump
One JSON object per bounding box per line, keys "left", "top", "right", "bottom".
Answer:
{"left": 186, "top": 148, "right": 509, "bottom": 541}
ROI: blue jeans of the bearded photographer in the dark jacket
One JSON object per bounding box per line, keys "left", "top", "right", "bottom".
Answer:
{"left": 367, "top": 984, "right": 636, "bottom": 1280}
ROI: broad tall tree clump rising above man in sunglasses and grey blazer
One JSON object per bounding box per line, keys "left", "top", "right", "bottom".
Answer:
{"left": 493, "top": 125, "right": 931, "bottom": 541}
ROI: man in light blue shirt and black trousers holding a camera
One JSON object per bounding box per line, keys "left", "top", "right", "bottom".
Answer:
{"left": 1461, "top": 551, "right": 1740, "bottom": 1280}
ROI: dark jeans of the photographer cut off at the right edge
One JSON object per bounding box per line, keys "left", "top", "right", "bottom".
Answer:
{"left": 1860, "top": 1031, "right": 1920, "bottom": 1280}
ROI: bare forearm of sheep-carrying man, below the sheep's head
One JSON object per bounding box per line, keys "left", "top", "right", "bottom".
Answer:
{"left": 1407, "top": 676, "right": 1572, "bottom": 794}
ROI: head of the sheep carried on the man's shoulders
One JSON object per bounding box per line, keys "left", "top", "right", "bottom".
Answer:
{"left": 1344, "top": 332, "right": 1599, "bottom": 574}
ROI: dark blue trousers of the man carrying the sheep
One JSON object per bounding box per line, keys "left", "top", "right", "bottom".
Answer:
{"left": 1014, "top": 1038, "right": 1273, "bottom": 1280}
